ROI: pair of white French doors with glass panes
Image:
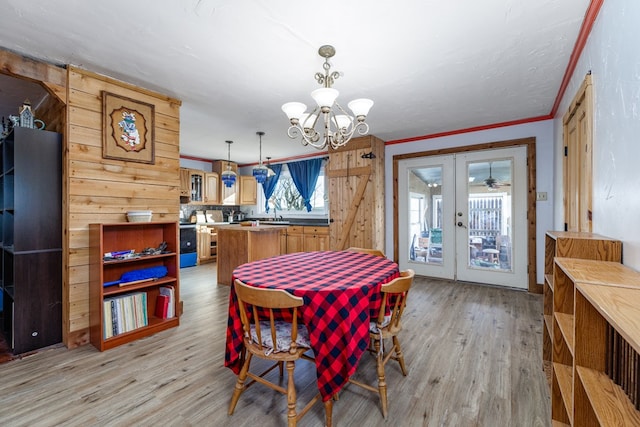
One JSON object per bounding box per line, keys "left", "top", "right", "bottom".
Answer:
{"left": 398, "top": 146, "right": 528, "bottom": 289}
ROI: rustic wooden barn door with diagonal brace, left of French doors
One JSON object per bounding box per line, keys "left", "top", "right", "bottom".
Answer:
{"left": 327, "top": 136, "right": 384, "bottom": 251}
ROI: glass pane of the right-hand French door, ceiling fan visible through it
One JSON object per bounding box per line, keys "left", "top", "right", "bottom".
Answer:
{"left": 467, "top": 159, "right": 513, "bottom": 271}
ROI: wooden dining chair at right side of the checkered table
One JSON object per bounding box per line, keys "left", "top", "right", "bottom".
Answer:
{"left": 349, "top": 269, "right": 415, "bottom": 418}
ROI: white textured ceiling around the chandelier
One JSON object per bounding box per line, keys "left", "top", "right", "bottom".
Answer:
{"left": 0, "top": 0, "right": 589, "bottom": 164}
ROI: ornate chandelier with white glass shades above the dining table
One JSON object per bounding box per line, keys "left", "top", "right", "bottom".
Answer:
{"left": 282, "top": 45, "right": 373, "bottom": 149}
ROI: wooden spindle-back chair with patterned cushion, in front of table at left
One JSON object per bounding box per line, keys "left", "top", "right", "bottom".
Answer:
{"left": 229, "top": 279, "right": 333, "bottom": 427}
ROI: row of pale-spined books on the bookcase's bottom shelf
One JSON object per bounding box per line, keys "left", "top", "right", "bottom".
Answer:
{"left": 103, "top": 292, "right": 149, "bottom": 339}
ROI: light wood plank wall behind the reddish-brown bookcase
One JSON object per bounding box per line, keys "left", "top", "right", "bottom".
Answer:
{"left": 63, "top": 66, "right": 181, "bottom": 348}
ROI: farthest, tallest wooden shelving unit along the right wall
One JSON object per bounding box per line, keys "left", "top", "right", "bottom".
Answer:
{"left": 542, "top": 231, "right": 622, "bottom": 377}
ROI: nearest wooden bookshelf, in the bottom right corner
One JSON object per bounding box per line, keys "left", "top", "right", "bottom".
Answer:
{"left": 573, "top": 284, "right": 640, "bottom": 426}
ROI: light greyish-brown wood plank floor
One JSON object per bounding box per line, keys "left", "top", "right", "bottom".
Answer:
{"left": 0, "top": 263, "right": 550, "bottom": 427}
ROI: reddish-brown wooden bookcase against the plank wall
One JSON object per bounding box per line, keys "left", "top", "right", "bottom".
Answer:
{"left": 89, "top": 222, "right": 181, "bottom": 351}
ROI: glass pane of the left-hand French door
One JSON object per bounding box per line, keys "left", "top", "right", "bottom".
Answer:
{"left": 408, "top": 166, "right": 442, "bottom": 264}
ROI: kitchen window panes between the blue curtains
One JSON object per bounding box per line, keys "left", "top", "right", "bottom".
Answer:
{"left": 258, "top": 164, "right": 329, "bottom": 217}
